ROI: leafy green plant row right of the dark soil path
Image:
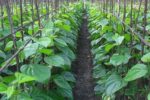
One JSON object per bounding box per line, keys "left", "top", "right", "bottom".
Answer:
{"left": 89, "top": 7, "right": 150, "bottom": 100}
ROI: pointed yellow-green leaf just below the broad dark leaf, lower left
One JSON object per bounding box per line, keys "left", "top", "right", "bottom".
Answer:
{"left": 15, "top": 72, "right": 35, "bottom": 84}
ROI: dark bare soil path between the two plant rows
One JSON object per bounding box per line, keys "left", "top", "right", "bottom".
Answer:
{"left": 72, "top": 11, "right": 95, "bottom": 100}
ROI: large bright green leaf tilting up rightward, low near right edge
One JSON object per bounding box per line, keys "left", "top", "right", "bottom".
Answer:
{"left": 124, "top": 64, "right": 148, "bottom": 82}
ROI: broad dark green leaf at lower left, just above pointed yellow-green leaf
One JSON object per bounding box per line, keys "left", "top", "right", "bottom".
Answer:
{"left": 21, "top": 64, "right": 51, "bottom": 82}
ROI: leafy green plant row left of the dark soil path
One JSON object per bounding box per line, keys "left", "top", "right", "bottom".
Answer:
{"left": 0, "top": 3, "right": 82, "bottom": 100}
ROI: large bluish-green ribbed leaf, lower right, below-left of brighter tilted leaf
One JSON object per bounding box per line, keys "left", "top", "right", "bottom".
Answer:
{"left": 105, "top": 73, "right": 127, "bottom": 96}
